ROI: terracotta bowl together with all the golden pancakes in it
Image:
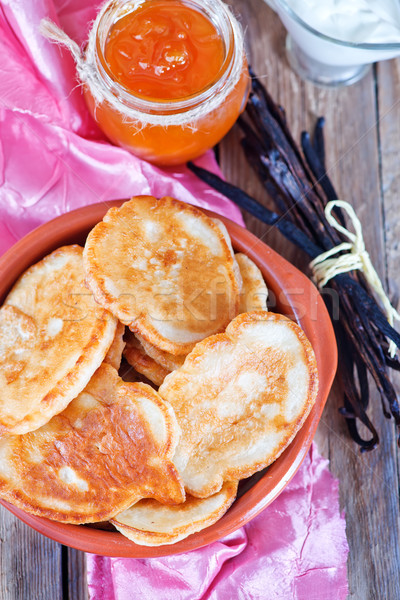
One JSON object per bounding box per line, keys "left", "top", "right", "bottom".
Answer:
{"left": 0, "top": 196, "right": 337, "bottom": 558}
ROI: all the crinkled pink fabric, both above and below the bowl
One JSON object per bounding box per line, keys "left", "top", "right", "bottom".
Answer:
{"left": 0, "top": 0, "right": 347, "bottom": 600}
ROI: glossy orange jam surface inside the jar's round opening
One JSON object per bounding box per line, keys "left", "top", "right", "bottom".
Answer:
{"left": 105, "top": 0, "right": 225, "bottom": 101}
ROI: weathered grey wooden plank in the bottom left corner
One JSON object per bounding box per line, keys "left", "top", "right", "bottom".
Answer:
{"left": 0, "top": 506, "right": 63, "bottom": 600}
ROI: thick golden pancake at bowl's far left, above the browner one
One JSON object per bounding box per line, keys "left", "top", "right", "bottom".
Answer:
{"left": 0, "top": 246, "right": 117, "bottom": 434}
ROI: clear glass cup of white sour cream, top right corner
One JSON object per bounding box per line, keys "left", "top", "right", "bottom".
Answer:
{"left": 266, "top": 0, "right": 400, "bottom": 86}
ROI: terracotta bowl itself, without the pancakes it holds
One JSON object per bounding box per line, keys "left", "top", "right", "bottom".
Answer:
{"left": 0, "top": 201, "right": 337, "bottom": 558}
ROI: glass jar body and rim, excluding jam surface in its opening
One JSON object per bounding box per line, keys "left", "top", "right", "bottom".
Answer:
{"left": 84, "top": 0, "right": 249, "bottom": 166}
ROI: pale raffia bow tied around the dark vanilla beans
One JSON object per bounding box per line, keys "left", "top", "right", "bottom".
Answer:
{"left": 310, "top": 200, "right": 400, "bottom": 358}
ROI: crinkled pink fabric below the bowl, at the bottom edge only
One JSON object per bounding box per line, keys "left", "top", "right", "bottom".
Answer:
{"left": 88, "top": 445, "right": 348, "bottom": 600}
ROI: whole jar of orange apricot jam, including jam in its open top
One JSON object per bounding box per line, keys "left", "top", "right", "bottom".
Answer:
{"left": 85, "top": 0, "right": 249, "bottom": 165}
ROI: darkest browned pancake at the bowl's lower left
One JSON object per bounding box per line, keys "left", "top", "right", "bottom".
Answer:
{"left": 0, "top": 364, "right": 185, "bottom": 523}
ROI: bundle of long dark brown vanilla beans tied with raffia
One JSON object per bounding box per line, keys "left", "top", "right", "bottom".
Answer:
{"left": 189, "top": 73, "right": 400, "bottom": 450}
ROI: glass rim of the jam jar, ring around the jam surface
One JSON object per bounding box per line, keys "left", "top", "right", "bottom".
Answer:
{"left": 92, "top": 0, "right": 244, "bottom": 116}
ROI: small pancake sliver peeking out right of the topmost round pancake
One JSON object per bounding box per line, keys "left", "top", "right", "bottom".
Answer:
{"left": 235, "top": 252, "right": 268, "bottom": 313}
